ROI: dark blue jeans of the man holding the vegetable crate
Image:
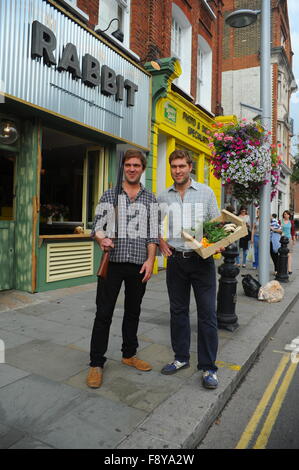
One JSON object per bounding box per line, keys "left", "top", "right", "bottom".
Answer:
{"left": 166, "top": 254, "right": 218, "bottom": 371}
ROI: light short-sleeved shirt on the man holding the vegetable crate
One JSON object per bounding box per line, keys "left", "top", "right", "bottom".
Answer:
{"left": 158, "top": 179, "right": 220, "bottom": 251}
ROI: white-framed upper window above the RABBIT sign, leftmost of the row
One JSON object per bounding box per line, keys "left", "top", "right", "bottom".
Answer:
{"left": 96, "top": 0, "right": 131, "bottom": 48}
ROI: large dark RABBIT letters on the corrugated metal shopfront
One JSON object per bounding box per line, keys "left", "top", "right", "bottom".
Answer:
{"left": 31, "top": 21, "right": 138, "bottom": 106}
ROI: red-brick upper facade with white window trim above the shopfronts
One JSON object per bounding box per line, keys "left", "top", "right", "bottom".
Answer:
{"left": 57, "top": 0, "right": 223, "bottom": 115}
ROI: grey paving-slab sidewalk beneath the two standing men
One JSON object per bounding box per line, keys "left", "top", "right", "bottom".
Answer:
{"left": 0, "top": 246, "right": 299, "bottom": 449}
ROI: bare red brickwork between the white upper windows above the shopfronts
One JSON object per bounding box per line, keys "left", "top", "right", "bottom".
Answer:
{"left": 74, "top": 0, "right": 224, "bottom": 114}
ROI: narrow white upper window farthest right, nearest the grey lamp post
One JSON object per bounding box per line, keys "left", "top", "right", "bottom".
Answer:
{"left": 196, "top": 36, "right": 212, "bottom": 111}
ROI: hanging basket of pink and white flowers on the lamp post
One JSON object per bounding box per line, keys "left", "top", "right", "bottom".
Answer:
{"left": 209, "top": 119, "right": 280, "bottom": 204}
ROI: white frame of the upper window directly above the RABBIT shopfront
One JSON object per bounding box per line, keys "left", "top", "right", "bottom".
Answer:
{"left": 95, "top": 0, "right": 131, "bottom": 50}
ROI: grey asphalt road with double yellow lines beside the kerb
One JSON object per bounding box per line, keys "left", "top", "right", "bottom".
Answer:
{"left": 198, "top": 301, "right": 299, "bottom": 449}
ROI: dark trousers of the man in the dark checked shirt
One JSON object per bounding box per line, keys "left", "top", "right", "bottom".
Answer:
{"left": 90, "top": 262, "right": 146, "bottom": 367}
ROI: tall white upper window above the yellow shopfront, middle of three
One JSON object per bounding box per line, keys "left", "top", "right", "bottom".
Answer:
{"left": 171, "top": 3, "right": 192, "bottom": 94}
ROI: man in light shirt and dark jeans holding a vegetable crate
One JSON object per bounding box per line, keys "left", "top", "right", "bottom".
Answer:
{"left": 158, "top": 150, "right": 219, "bottom": 389}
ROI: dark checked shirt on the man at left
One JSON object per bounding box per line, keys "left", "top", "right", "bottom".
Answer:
{"left": 91, "top": 184, "right": 159, "bottom": 264}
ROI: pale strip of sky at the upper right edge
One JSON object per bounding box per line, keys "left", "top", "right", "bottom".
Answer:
{"left": 288, "top": 0, "right": 299, "bottom": 152}
